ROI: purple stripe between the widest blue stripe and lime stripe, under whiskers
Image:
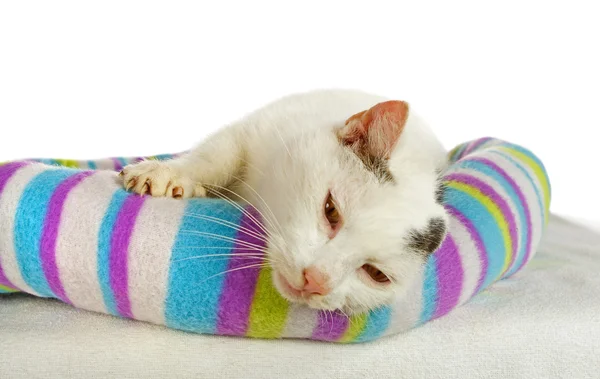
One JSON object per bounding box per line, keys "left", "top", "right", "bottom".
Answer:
{"left": 217, "top": 207, "right": 265, "bottom": 336}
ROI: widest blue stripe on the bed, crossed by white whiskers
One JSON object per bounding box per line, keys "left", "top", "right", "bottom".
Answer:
{"left": 165, "top": 199, "right": 241, "bottom": 334}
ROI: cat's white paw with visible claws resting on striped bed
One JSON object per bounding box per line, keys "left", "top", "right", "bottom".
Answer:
{"left": 119, "top": 160, "right": 206, "bottom": 199}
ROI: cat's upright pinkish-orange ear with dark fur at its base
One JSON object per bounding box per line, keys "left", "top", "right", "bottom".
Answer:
{"left": 337, "top": 100, "right": 408, "bottom": 159}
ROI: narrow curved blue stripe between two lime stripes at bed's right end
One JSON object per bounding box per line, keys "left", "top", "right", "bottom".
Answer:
{"left": 457, "top": 159, "right": 529, "bottom": 276}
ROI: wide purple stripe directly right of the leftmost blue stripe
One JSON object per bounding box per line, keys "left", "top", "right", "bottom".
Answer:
{"left": 40, "top": 171, "right": 93, "bottom": 304}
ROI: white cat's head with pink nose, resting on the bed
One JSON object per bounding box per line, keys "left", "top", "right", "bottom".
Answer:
{"left": 257, "top": 101, "right": 447, "bottom": 313}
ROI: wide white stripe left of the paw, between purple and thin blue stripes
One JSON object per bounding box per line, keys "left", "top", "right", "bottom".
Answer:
{"left": 56, "top": 171, "right": 119, "bottom": 313}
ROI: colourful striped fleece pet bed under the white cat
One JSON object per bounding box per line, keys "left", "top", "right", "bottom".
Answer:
{"left": 0, "top": 138, "right": 551, "bottom": 343}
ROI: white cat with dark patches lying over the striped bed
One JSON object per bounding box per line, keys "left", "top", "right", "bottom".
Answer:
{"left": 122, "top": 90, "right": 447, "bottom": 314}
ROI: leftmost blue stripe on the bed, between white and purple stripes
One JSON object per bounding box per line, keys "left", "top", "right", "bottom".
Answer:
{"left": 14, "top": 169, "right": 79, "bottom": 297}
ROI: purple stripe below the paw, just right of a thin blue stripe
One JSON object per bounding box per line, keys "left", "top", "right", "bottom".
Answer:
{"left": 109, "top": 195, "right": 146, "bottom": 318}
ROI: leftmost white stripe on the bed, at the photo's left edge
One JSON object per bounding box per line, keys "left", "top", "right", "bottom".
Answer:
{"left": 0, "top": 164, "right": 51, "bottom": 296}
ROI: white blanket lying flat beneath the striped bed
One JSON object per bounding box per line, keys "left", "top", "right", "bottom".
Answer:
{"left": 0, "top": 217, "right": 600, "bottom": 379}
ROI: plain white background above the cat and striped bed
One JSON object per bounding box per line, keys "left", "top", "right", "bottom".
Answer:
{"left": 0, "top": 0, "right": 600, "bottom": 223}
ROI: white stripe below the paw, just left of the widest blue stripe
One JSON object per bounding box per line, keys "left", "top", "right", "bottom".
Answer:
{"left": 127, "top": 198, "right": 185, "bottom": 324}
